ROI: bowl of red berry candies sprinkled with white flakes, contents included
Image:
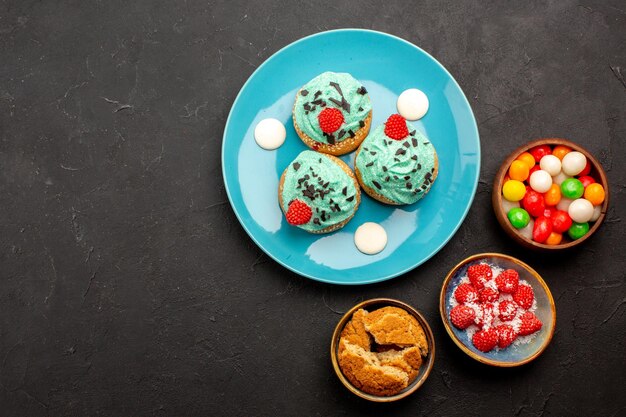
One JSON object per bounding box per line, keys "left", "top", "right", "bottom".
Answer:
{"left": 439, "top": 253, "right": 556, "bottom": 367}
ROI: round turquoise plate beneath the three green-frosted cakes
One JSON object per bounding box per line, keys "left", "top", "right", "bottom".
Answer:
{"left": 222, "top": 29, "right": 480, "bottom": 284}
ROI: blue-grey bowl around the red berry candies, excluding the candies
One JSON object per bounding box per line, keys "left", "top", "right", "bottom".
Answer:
{"left": 439, "top": 253, "right": 556, "bottom": 368}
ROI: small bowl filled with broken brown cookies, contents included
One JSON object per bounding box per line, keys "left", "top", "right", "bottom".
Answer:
{"left": 330, "top": 298, "right": 435, "bottom": 402}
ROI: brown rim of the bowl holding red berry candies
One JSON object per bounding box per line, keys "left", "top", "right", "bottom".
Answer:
{"left": 439, "top": 252, "right": 556, "bottom": 368}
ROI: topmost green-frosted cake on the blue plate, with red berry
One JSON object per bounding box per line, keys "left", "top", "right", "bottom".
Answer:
{"left": 293, "top": 72, "right": 372, "bottom": 155}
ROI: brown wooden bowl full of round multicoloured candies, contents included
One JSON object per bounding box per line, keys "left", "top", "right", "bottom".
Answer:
{"left": 492, "top": 138, "right": 609, "bottom": 251}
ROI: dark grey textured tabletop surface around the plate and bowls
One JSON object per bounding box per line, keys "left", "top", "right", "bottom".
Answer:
{"left": 0, "top": 0, "right": 626, "bottom": 416}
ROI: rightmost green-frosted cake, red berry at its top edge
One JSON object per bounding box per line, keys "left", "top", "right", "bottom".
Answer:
{"left": 354, "top": 114, "right": 439, "bottom": 205}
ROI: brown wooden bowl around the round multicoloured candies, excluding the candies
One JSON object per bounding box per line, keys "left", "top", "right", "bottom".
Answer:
{"left": 491, "top": 138, "right": 609, "bottom": 252}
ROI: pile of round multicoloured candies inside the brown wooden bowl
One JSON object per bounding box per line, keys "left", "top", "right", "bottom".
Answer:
{"left": 502, "top": 145, "right": 606, "bottom": 246}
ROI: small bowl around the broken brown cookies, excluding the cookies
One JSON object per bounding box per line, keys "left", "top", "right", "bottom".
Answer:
{"left": 330, "top": 298, "right": 435, "bottom": 402}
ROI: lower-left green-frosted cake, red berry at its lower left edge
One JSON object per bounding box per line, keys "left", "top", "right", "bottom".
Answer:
{"left": 278, "top": 151, "right": 361, "bottom": 233}
